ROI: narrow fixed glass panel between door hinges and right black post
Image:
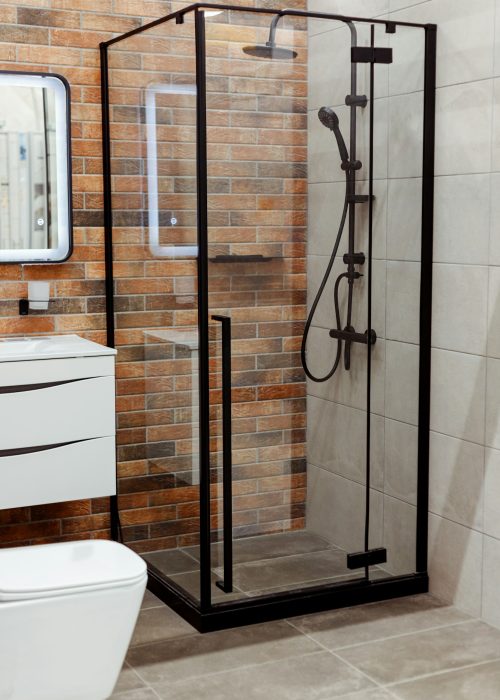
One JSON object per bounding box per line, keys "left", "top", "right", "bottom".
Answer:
{"left": 371, "top": 26, "right": 428, "bottom": 575}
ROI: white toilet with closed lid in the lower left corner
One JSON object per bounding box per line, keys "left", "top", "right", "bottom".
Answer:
{"left": 0, "top": 540, "right": 147, "bottom": 700}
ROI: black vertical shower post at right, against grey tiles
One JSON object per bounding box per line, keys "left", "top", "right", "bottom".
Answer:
{"left": 416, "top": 24, "right": 437, "bottom": 573}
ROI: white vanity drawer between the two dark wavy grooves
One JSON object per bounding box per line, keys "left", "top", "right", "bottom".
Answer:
{"left": 0, "top": 376, "right": 115, "bottom": 450}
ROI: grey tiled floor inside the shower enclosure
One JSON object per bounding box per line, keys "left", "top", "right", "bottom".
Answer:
{"left": 144, "top": 530, "right": 377, "bottom": 601}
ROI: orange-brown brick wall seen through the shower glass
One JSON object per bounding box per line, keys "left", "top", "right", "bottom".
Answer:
{"left": 110, "top": 5, "right": 307, "bottom": 551}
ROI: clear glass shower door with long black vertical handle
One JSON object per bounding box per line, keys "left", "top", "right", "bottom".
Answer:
{"left": 205, "top": 11, "right": 372, "bottom": 602}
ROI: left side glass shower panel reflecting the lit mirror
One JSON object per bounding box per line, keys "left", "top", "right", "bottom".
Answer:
{"left": 109, "top": 10, "right": 200, "bottom": 598}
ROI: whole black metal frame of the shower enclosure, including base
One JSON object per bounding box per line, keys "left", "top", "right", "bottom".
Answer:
{"left": 100, "top": 3, "right": 437, "bottom": 632}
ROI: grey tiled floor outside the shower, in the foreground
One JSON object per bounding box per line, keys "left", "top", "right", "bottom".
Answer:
{"left": 112, "top": 592, "right": 500, "bottom": 700}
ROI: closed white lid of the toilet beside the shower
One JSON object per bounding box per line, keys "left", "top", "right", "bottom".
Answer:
{"left": 0, "top": 540, "right": 146, "bottom": 601}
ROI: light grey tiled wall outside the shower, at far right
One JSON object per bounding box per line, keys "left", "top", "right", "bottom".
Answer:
{"left": 309, "top": 0, "right": 500, "bottom": 624}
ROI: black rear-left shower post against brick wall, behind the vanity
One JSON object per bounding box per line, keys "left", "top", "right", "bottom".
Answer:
{"left": 99, "top": 43, "right": 122, "bottom": 542}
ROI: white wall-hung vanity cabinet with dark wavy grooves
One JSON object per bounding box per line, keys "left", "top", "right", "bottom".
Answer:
{"left": 0, "top": 335, "right": 116, "bottom": 508}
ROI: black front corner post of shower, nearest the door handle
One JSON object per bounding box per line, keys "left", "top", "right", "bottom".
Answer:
{"left": 194, "top": 10, "right": 212, "bottom": 613}
